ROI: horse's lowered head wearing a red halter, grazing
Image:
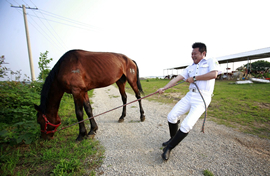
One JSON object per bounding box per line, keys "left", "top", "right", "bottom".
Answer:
{"left": 35, "top": 105, "right": 61, "bottom": 139}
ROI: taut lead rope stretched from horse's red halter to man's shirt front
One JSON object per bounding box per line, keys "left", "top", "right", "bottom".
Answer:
{"left": 57, "top": 81, "right": 185, "bottom": 131}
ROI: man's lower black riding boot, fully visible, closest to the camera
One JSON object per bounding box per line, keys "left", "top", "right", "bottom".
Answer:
{"left": 161, "top": 130, "right": 188, "bottom": 160}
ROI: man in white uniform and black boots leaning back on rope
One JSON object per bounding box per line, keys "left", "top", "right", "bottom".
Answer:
{"left": 158, "top": 43, "right": 219, "bottom": 160}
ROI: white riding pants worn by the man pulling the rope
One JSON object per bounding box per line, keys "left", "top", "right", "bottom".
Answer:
{"left": 167, "top": 91, "right": 212, "bottom": 133}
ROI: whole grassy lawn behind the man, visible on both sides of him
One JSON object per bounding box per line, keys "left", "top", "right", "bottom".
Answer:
{"left": 124, "top": 79, "right": 270, "bottom": 139}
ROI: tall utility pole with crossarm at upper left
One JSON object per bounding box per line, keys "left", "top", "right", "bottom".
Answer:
{"left": 11, "top": 5, "right": 38, "bottom": 81}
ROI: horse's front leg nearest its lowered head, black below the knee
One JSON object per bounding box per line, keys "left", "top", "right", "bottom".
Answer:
{"left": 73, "top": 95, "right": 87, "bottom": 141}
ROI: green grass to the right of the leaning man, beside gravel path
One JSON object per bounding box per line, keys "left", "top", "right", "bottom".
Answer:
{"left": 209, "top": 81, "right": 270, "bottom": 139}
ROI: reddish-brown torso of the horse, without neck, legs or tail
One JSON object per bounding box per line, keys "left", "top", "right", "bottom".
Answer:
{"left": 58, "top": 50, "right": 136, "bottom": 90}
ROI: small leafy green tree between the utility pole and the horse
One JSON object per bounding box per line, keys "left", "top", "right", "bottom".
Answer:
{"left": 38, "top": 51, "right": 53, "bottom": 80}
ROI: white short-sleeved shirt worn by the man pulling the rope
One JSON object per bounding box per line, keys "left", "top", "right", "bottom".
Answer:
{"left": 180, "top": 58, "right": 220, "bottom": 94}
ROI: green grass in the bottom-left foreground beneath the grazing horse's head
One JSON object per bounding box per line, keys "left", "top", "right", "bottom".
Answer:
{"left": 0, "top": 92, "right": 104, "bottom": 175}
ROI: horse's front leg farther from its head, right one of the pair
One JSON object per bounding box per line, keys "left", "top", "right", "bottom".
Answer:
{"left": 83, "top": 92, "right": 98, "bottom": 138}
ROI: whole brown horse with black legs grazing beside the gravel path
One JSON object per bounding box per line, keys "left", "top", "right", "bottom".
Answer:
{"left": 35, "top": 50, "right": 145, "bottom": 140}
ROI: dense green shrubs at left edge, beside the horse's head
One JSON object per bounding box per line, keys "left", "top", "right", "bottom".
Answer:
{"left": 0, "top": 82, "right": 43, "bottom": 144}
